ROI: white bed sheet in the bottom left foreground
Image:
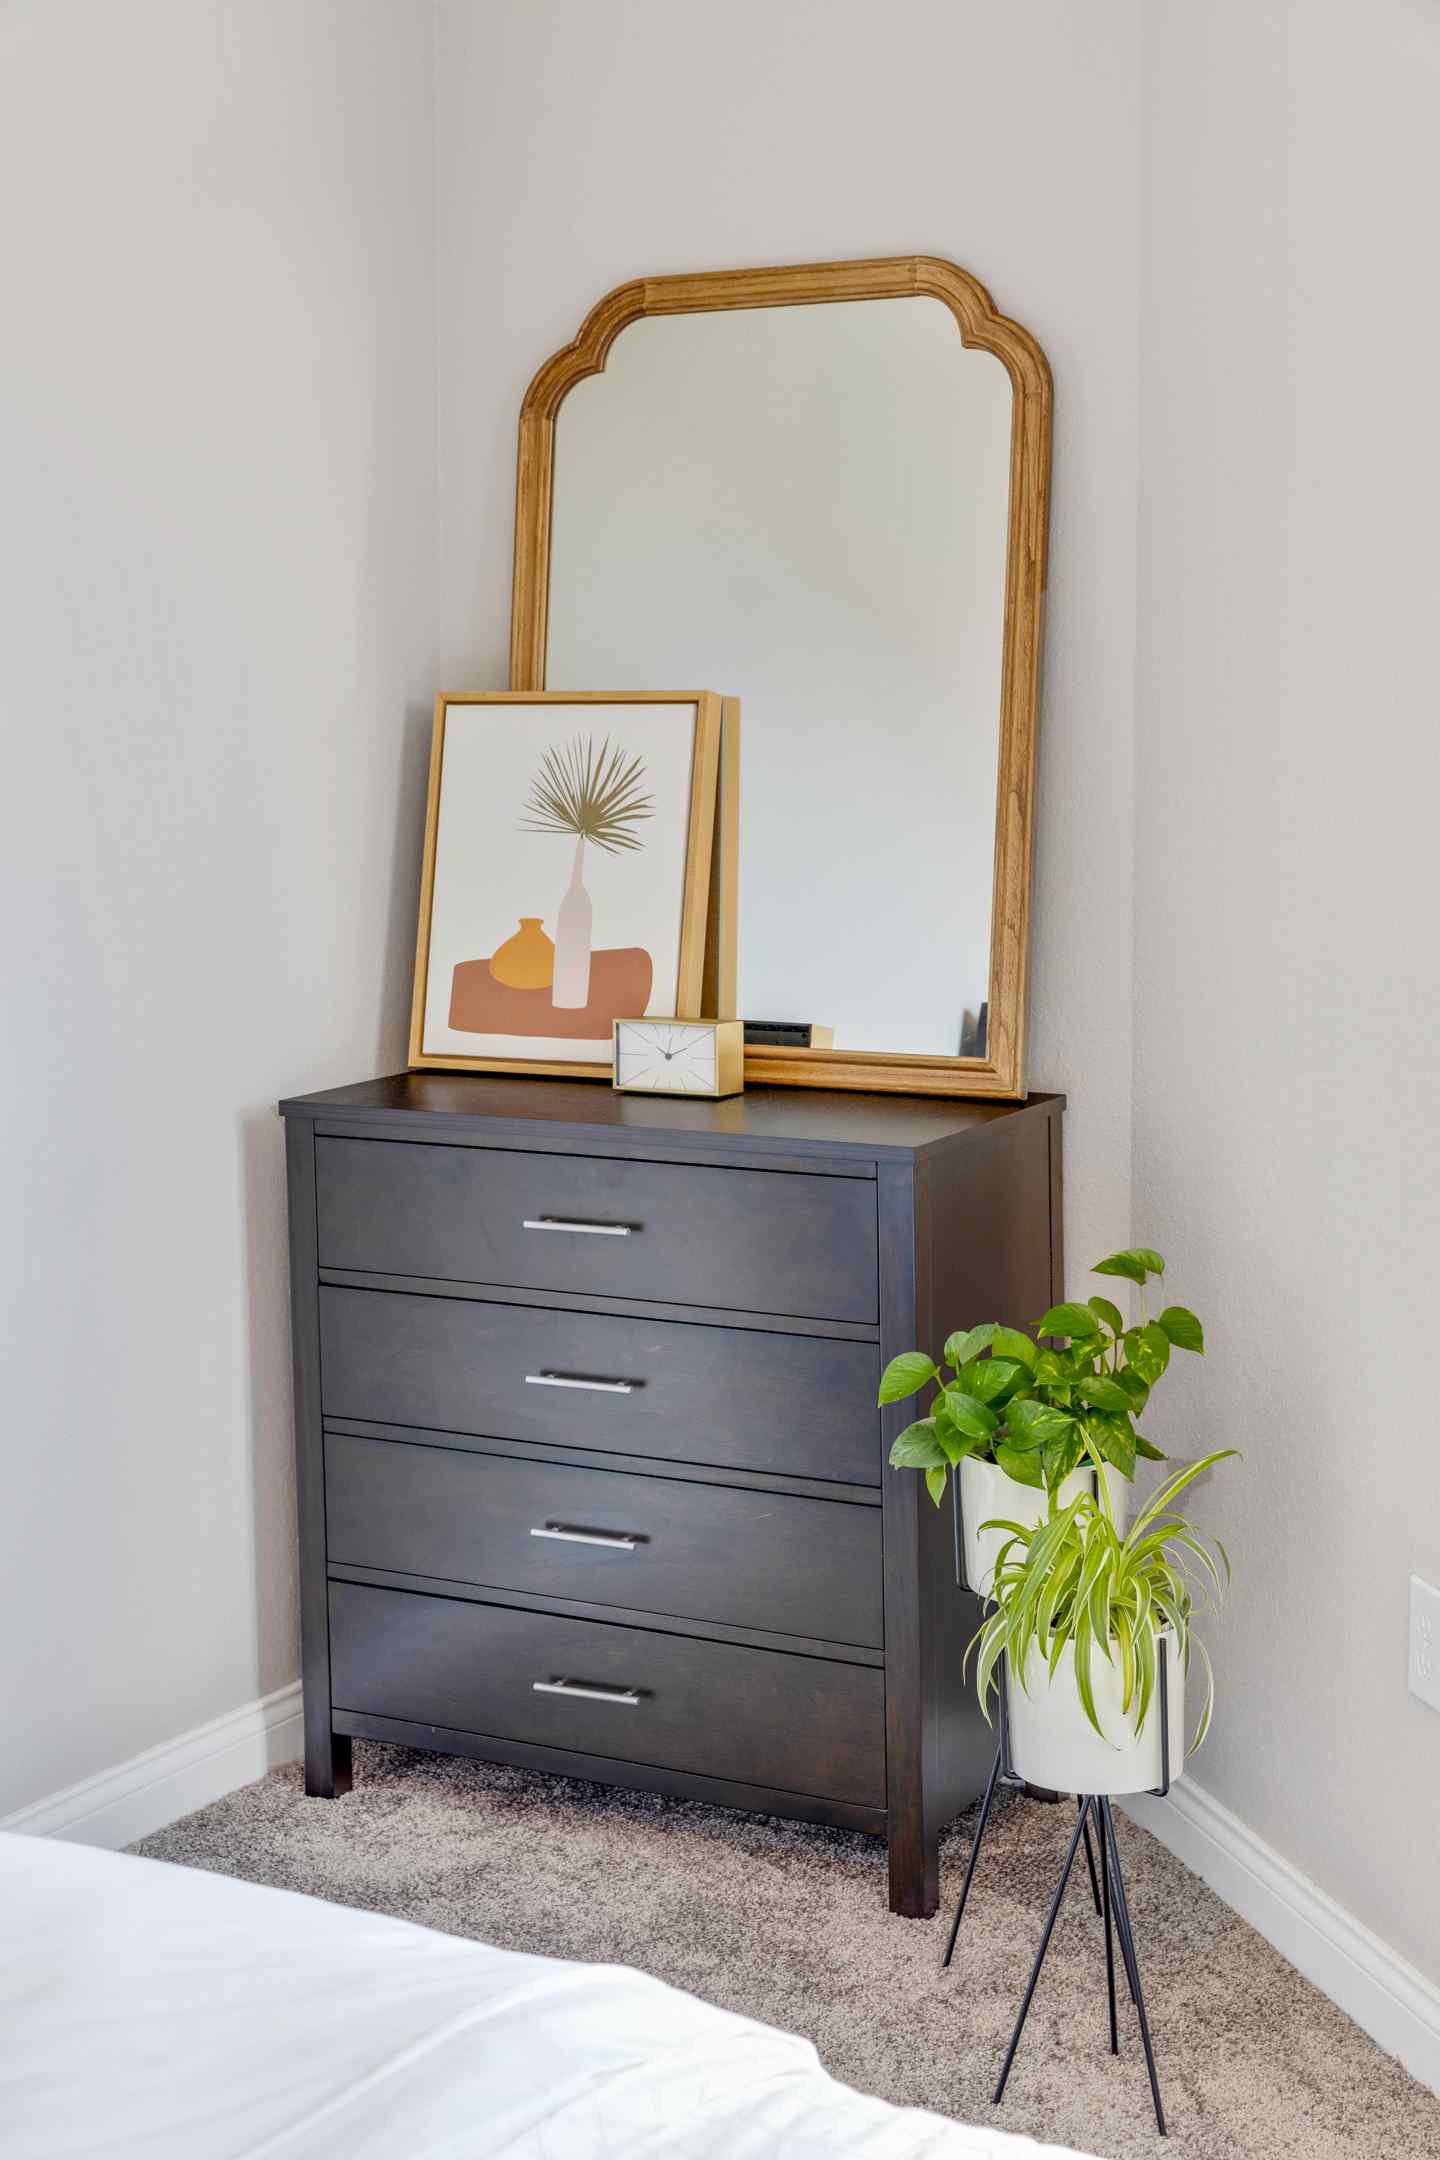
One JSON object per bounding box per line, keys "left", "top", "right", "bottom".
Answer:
{"left": 0, "top": 1836, "right": 1092, "bottom": 2160}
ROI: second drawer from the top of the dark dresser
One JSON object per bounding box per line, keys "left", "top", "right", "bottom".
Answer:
{"left": 320, "top": 1287, "right": 881, "bottom": 1484}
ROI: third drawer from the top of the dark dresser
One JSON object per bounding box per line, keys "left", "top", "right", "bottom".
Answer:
{"left": 326, "top": 1432, "right": 883, "bottom": 1648}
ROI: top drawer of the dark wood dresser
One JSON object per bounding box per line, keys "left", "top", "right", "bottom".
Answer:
{"left": 315, "top": 1138, "right": 879, "bottom": 1324}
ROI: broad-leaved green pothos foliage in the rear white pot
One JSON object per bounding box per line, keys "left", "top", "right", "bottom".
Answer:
{"left": 879, "top": 1244, "right": 1205, "bottom": 1508}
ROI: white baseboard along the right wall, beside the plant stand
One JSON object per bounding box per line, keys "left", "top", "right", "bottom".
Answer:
{"left": 1125, "top": 1778, "right": 1440, "bottom": 2093}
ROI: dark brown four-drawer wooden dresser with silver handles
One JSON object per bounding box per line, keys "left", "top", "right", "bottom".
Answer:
{"left": 281, "top": 1074, "right": 1062, "bottom": 1916}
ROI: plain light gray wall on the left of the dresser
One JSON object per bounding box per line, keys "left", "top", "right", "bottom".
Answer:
{"left": 0, "top": 0, "right": 434, "bottom": 1817}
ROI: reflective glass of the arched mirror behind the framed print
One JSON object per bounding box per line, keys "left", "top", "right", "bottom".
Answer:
{"left": 546, "top": 296, "right": 1013, "bottom": 1056}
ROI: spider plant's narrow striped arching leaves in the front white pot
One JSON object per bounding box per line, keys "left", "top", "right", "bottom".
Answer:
{"left": 965, "top": 1447, "right": 1235, "bottom": 1754}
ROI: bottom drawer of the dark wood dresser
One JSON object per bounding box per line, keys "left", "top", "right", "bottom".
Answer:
{"left": 330, "top": 1583, "right": 885, "bottom": 1808}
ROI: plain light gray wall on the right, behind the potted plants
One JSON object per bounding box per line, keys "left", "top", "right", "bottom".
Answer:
{"left": 1139, "top": 0, "right": 1440, "bottom": 1979}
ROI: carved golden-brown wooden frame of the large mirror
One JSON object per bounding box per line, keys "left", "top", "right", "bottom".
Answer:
{"left": 510, "top": 255, "right": 1051, "bottom": 1097}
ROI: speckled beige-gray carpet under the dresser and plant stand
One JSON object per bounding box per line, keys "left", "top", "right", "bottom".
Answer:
{"left": 136, "top": 1743, "right": 1440, "bottom": 2160}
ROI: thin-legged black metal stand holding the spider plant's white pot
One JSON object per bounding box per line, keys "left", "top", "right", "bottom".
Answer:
{"left": 941, "top": 1635, "right": 1170, "bottom": 2138}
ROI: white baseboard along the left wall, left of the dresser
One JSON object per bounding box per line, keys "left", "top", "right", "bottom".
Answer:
{"left": 0, "top": 1680, "right": 302, "bottom": 1853}
